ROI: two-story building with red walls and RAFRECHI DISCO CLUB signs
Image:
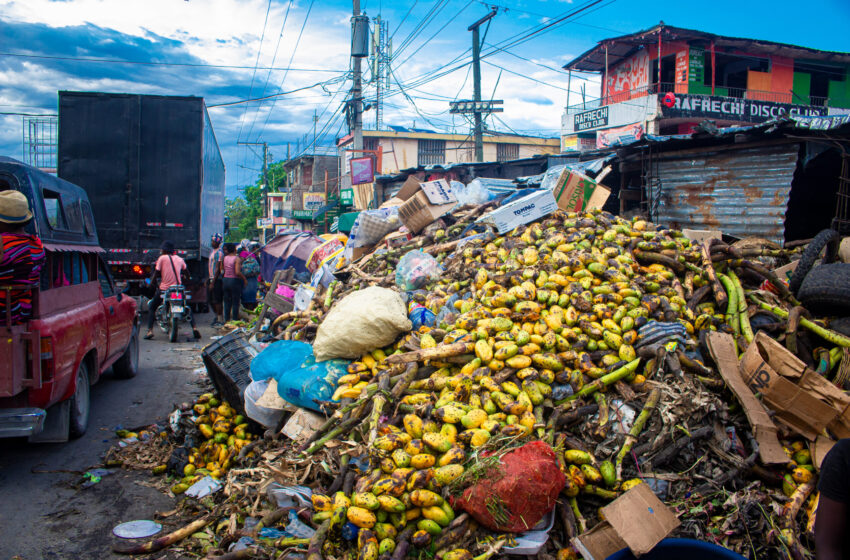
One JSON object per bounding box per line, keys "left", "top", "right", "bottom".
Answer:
{"left": 561, "top": 22, "right": 850, "bottom": 151}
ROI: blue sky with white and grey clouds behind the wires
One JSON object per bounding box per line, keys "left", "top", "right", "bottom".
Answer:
{"left": 0, "top": 0, "right": 850, "bottom": 195}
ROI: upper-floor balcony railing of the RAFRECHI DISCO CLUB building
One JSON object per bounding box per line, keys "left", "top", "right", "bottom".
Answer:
{"left": 566, "top": 82, "right": 829, "bottom": 115}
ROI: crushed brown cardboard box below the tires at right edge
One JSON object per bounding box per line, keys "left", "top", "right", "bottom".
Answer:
{"left": 739, "top": 331, "right": 840, "bottom": 440}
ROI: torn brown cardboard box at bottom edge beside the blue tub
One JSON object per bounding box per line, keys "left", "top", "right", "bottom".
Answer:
{"left": 572, "top": 484, "right": 679, "bottom": 560}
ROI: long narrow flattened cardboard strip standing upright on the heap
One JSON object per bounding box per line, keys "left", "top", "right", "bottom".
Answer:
{"left": 708, "top": 332, "right": 788, "bottom": 465}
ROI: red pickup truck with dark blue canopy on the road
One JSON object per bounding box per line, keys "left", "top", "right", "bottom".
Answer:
{"left": 0, "top": 157, "right": 139, "bottom": 441}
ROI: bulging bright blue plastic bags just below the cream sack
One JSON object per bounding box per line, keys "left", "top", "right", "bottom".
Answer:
{"left": 251, "top": 340, "right": 350, "bottom": 412}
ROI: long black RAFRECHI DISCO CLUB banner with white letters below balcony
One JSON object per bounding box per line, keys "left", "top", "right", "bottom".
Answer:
{"left": 660, "top": 94, "right": 827, "bottom": 122}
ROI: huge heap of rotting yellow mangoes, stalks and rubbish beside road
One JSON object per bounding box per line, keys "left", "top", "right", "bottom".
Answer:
{"left": 112, "top": 203, "right": 850, "bottom": 560}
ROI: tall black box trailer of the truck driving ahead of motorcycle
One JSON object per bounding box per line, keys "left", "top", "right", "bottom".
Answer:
{"left": 58, "top": 91, "right": 225, "bottom": 311}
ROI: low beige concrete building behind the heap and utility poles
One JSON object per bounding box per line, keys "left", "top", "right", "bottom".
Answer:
{"left": 337, "top": 126, "right": 560, "bottom": 188}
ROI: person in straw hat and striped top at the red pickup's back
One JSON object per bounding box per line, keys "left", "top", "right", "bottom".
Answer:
{"left": 0, "top": 190, "right": 46, "bottom": 325}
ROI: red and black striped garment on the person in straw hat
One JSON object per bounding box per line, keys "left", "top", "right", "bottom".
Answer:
{"left": 0, "top": 233, "right": 45, "bottom": 325}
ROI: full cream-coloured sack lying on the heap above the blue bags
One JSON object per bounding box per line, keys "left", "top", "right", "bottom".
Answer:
{"left": 313, "top": 286, "right": 413, "bottom": 362}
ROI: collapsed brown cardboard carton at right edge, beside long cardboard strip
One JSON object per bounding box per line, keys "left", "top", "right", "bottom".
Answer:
{"left": 739, "top": 331, "right": 850, "bottom": 441}
